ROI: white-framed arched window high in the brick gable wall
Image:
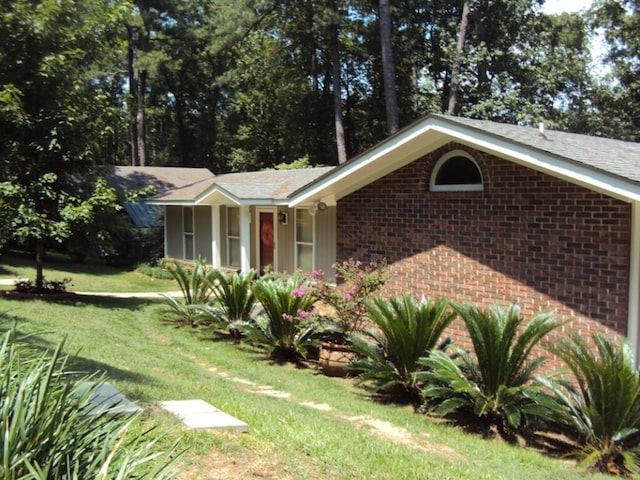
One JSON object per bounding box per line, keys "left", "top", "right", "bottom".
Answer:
{"left": 429, "top": 150, "right": 482, "bottom": 192}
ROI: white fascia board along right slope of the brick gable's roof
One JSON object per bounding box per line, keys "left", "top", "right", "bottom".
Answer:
{"left": 434, "top": 125, "right": 640, "bottom": 202}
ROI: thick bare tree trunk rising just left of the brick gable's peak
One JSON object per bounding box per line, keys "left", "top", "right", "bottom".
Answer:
{"left": 379, "top": 0, "right": 400, "bottom": 135}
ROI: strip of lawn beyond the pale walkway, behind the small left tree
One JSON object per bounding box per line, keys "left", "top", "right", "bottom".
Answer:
{"left": 0, "top": 255, "right": 178, "bottom": 292}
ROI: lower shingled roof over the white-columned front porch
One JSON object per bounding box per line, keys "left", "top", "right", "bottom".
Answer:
{"left": 148, "top": 167, "right": 334, "bottom": 205}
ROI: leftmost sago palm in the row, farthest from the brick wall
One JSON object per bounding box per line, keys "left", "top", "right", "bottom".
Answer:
{"left": 164, "top": 258, "right": 214, "bottom": 324}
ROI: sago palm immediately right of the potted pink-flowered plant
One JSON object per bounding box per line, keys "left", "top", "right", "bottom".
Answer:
{"left": 349, "top": 295, "right": 456, "bottom": 402}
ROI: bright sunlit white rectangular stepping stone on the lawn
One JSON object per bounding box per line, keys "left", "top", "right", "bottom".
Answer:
{"left": 160, "top": 400, "right": 249, "bottom": 433}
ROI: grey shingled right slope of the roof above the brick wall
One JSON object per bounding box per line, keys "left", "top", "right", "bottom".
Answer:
{"left": 432, "top": 115, "right": 640, "bottom": 186}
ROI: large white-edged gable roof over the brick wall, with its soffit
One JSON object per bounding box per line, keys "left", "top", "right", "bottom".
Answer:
{"left": 290, "top": 114, "right": 640, "bottom": 206}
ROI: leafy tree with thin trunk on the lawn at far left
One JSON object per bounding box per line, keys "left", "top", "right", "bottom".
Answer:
{"left": 0, "top": 0, "right": 120, "bottom": 289}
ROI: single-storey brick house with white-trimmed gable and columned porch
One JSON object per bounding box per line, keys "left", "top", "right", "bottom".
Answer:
{"left": 144, "top": 115, "right": 640, "bottom": 357}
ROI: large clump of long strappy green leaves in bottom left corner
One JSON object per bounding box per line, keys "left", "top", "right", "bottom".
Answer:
{"left": 0, "top": 332, "right": 179, "bottom": 480}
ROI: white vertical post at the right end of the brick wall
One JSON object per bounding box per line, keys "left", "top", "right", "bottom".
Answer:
{"left": 627, "top": 201, "right": 640, "bottom": 367}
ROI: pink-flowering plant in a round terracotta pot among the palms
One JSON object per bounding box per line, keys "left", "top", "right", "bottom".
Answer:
{"left": 314, "top": 259, "right": 388, "bottom": 377}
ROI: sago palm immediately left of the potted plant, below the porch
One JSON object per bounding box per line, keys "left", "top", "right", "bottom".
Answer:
{"left": 236, "top": 277, "right": 317, "bottom": 359}
